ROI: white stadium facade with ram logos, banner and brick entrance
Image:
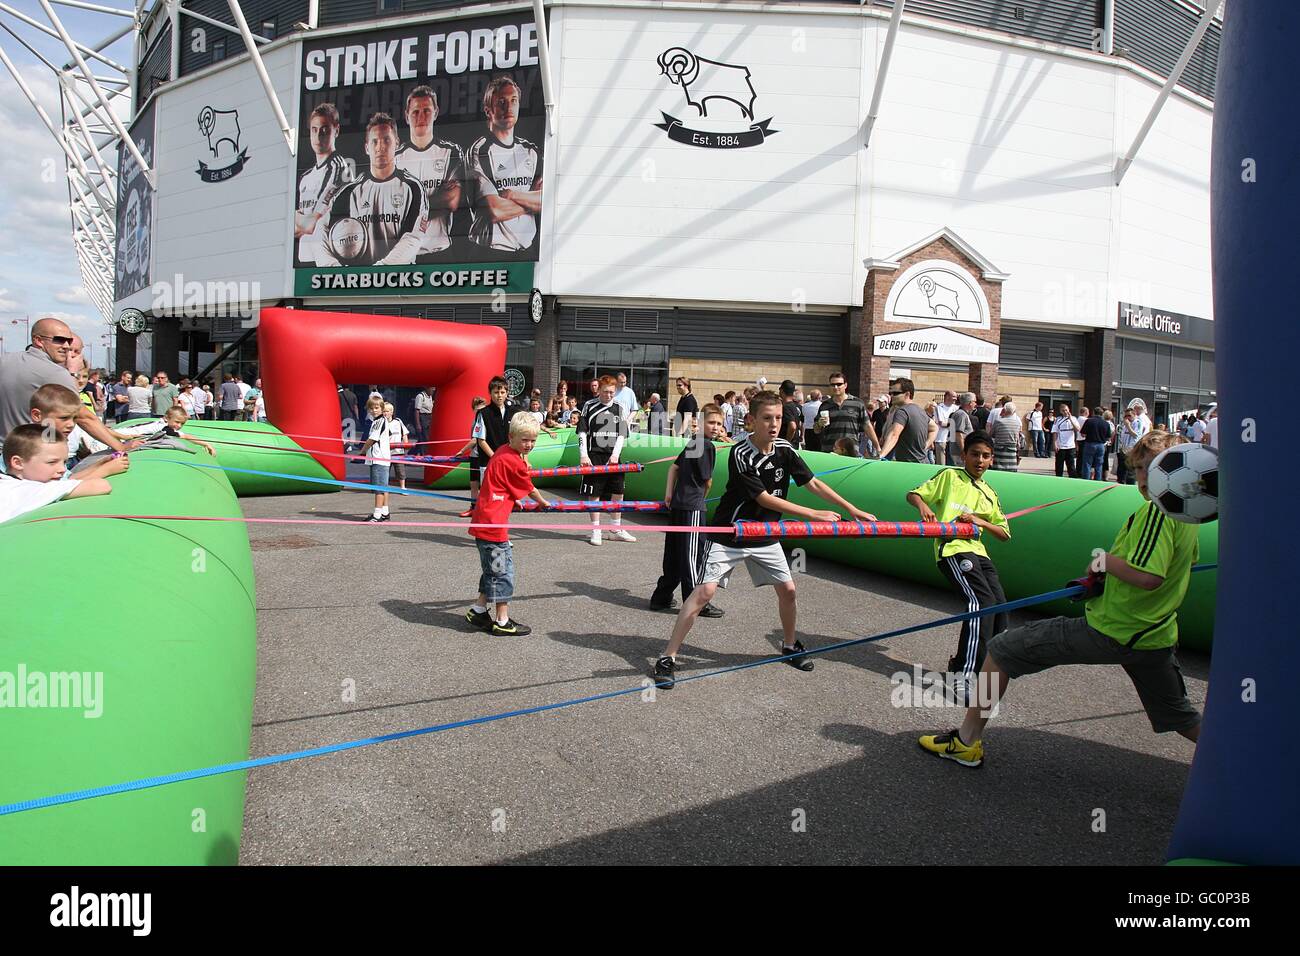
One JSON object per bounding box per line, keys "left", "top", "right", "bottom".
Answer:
{"left": 15, "top": 0, "right": 1222, "bottom": 418}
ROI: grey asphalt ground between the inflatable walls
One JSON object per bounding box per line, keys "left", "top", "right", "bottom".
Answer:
{"left": 241, "top": 478, "right": 1209, "bottom": 864}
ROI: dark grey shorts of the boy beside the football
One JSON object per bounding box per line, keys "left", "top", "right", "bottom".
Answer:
{"left": 988, "top": 618, "right": 1201, "bottom": 734}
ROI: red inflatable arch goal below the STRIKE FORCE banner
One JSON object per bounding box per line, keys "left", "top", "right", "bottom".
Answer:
{"left": 257, "top": 308, "right": 506, "bottom": 480}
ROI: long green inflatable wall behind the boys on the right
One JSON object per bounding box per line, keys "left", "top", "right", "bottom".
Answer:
{"left": 603, "top": 436, "right": 1218, "bottom": 652}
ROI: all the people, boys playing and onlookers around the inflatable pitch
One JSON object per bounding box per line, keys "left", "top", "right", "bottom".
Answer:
{"left": 0, "top": 319, "right": 1217, "bottom": 767}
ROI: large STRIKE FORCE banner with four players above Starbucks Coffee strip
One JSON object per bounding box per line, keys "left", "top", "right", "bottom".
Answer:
{"left": 293, "top": 12, "right": 546, "bottom": 297}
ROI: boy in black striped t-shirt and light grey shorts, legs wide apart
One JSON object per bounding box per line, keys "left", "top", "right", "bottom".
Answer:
{"left": 654, "top": 390, "right": 876, "bottom": 689}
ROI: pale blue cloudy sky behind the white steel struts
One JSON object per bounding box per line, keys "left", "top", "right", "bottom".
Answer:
{"left": 0, "top": 0, "right": 143, "bottom": 365}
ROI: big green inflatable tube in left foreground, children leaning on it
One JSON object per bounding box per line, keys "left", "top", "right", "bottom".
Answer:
{"left": 0, "top": 450, "right": 256, "bottom": 866}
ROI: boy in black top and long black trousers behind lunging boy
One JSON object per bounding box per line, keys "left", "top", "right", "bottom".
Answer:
{"left": 650, "top": 405, "right": 727, "bottom": 618}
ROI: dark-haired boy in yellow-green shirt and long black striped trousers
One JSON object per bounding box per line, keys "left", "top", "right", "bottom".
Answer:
{"left": 907, "top": 432, "right": 1011, "bottom": 704}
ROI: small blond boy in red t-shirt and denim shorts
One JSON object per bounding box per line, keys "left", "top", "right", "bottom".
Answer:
{"left": 465, "top": 415, "right": 549, "bottom": 637}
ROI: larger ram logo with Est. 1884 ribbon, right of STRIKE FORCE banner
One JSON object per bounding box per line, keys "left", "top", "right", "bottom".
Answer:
{"left": 655, "top": 47, "right": 780, "bottom": 150}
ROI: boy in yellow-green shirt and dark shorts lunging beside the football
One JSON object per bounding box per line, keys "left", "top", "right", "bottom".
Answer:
{"left": 919, "top": 432, "right": 1201, "bottom": 767}
